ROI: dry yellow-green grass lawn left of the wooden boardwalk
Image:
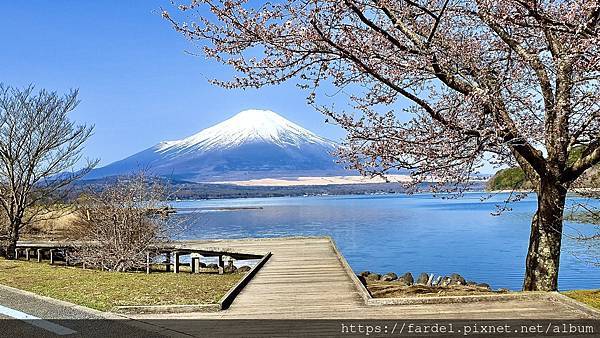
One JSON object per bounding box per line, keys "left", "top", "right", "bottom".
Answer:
{"left": 0, "top": 258, "right": 244, "bottom": 311}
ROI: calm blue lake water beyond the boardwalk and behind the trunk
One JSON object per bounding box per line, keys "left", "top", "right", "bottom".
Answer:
{"left": 174, "top": 193, "right": 600, "bottom": 290}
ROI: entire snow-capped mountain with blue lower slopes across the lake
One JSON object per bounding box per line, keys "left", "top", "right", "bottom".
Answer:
{"left": 85, "top": 110, "right": 348, "bottom": 182}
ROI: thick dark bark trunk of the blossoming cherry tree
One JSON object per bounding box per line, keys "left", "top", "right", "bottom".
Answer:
{"left": 523, "top": 179, "right": 567, "bottom": 291}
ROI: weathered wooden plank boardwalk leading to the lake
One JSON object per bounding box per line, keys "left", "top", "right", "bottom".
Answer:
{"left": 131, "top": 238, "right": 590, "bottom": 319}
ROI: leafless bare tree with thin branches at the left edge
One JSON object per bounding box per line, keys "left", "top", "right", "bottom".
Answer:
{"left": 0, "top": 84, "right": 95, "bottom": 258}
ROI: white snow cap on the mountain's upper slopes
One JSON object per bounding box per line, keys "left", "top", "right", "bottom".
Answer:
{"left": 157, "top": 109, "right": 335, "bottom": 152}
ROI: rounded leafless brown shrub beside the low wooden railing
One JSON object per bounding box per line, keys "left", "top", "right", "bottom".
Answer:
{"left": 71, "top": 173, "right": 179, "bottom": 271}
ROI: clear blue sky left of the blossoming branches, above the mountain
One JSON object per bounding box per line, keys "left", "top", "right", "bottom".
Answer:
{"left": 0, "top": 0, "right": 344, "bottom": 165}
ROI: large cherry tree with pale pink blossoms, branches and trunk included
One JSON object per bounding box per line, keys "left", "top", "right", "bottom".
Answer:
{"left": 163, "top": 0, "right": 600, "bottom": 290}
